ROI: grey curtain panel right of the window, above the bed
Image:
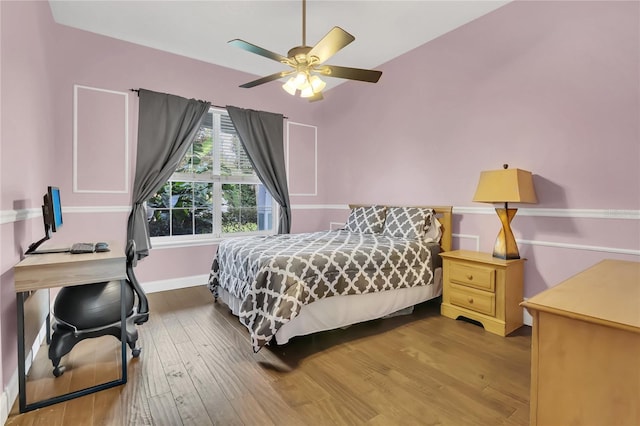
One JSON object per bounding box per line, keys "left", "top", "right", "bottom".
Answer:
{"left": 227, "top": 105, "right": 291, "bottom": 234}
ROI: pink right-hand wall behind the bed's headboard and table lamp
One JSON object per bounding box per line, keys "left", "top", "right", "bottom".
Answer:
{"left": 317, "top": 1, "right": 640, "bottom": 296}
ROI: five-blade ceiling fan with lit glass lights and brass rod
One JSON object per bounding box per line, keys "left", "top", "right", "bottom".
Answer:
{"left": 229, "top": 0, "right": 382, "bottom": 101}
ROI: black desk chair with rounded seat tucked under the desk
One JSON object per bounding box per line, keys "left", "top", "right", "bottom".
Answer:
{"left": 49, "top": 240, "right": 149, "bottom": 377}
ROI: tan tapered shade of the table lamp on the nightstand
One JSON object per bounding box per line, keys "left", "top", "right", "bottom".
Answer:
{"left": 473, "top": 168, "right": 538, "bottom": 204}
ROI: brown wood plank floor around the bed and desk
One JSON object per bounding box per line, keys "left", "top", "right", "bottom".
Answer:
{"left": 6, "top": 287, "right": 531, "bottom": 426}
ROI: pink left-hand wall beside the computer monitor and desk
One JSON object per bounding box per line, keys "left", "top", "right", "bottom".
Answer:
{"left": 0, "top": 3, "right": 62, "bottom": 389}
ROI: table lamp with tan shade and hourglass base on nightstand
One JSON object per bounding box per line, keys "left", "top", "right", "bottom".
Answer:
{"left": 473, "top": 164, "right": 538, "bottom": 259}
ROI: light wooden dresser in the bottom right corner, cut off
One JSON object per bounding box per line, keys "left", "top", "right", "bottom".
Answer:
{"left": 522, "top": 260, "right": 640, "bottom": 426}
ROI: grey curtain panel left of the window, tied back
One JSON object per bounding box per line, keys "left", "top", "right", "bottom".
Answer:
{"left": 127, "top": 89, "right": 210, "bottom": 259}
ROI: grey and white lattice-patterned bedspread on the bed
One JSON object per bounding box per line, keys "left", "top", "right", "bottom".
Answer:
{"left": 208, "top": 230, "right": 439, "bottom": 352}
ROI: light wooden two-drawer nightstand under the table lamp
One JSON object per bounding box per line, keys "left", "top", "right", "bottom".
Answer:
{"left": 440, "top": 250, "right": 525, "bottom": 336}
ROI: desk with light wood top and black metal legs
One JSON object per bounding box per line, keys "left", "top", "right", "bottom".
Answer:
{"left": 14, "top": 242, "right": 127, "bottom": 413}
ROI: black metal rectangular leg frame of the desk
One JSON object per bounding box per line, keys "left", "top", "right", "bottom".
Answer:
{"left": 17, "top": 280, "right": 127, "bottom": 413}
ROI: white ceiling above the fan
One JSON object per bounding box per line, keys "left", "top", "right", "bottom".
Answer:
{"left": 49, "top": 0, "right": 510, "bottom": 88}
